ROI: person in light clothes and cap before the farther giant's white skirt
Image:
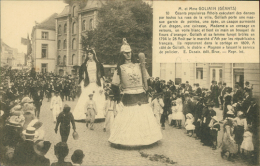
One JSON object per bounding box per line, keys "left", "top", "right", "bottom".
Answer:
{"left": 85, "top": 93, "right": 97, "bottom": 130}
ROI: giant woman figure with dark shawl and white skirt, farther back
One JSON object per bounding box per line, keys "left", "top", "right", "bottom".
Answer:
{"left": 73, "top": 49, "right": 105, "bottom": 120}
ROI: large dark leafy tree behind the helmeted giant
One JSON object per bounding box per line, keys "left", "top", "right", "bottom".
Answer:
{"left": 82, "top": 0, "right": 153, "bottom": 73}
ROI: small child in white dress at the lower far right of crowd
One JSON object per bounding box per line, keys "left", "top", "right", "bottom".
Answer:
{"left": 241, "top": 126, "right": 254, "bottom": 157}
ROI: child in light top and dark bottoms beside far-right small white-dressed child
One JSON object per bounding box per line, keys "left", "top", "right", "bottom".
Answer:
{"left": 234, "top": 111, "right": 247, "bottom": 153}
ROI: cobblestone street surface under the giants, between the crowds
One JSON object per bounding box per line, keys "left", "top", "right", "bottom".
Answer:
{"left": 40, "top": 98, "right": 246, "bottom": 166}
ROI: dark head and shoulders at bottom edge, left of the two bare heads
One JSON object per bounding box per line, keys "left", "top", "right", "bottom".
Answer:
{"left": 51, "top": 142, "right": 73, "bottom": 166}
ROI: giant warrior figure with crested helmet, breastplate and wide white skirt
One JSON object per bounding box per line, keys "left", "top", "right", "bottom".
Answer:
{"left": 108, "top": 39, "right": 162, "bottom": 146}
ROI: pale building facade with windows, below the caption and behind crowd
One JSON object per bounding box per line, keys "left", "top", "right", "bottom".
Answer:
{"left": 153, "top": 61, "right": 260, "bottom": 98}
